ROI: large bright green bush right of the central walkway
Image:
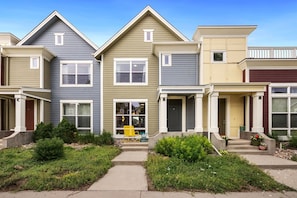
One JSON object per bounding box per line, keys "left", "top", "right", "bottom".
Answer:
{"left": 155, "top": 135, "right": 212, "bottom": 162}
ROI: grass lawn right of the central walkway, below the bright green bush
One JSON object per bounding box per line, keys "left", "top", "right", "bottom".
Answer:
{"left": 146, "top": 154, "right": 293, "bottom": 193}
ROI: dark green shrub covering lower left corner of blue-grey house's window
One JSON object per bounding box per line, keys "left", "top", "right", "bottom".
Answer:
{"left": 53, "top": 119, "right": 77, "bottom": 144}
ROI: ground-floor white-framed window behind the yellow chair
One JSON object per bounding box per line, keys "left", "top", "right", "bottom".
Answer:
{"left": 114, "top": 100, "right": 147, "bottom": 135}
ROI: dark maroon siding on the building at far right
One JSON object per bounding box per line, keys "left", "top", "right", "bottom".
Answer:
{"left": 250, "top": 70, "right": 297, "bottom": 132}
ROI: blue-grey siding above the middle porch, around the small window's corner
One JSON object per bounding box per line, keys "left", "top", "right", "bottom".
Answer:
{"left": 161, "top": 54, "right": 199, "bottom": 85}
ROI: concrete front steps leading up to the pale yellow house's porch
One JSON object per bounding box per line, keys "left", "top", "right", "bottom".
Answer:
{"left": 227, "top": 139, "right": 269, "bottom": 155}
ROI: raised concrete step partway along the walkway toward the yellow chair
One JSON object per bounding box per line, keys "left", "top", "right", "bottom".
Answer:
{"left": 112, "top": 151, "right": 148, "bottom": 166}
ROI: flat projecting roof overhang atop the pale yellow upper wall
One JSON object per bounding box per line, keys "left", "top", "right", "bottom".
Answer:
{"left": 193, "top": 25, "right": 257, "bottom": 41}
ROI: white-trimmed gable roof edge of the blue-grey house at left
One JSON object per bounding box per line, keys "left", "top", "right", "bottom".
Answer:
{"left": 17, "top": 11, "right": 98, "bottom": 50}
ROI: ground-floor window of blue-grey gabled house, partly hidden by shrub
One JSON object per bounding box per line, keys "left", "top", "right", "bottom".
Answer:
{"left": 61, "top": 101, "right": 92, "bottom": 133}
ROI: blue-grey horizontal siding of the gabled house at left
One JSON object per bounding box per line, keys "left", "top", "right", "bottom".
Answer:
{"left": 25, "top": 20, "right": 100, "bottom": 133}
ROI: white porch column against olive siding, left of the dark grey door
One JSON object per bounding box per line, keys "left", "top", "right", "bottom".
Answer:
{"left": 159, "top": 94, "right": 168, "bottom": 133}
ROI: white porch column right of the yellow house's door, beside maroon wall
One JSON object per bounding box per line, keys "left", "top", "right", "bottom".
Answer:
{"left": 252, "top": 92, "right": 264, "bottom": 132}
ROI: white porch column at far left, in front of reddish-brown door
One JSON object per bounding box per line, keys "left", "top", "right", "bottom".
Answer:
{"left": 14, "top": 94, "right": 26, "bottom": 132}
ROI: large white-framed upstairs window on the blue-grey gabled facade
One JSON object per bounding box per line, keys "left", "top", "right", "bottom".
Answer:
{"left": 61, "top": 61, "right": 93, "bottom": 86}
